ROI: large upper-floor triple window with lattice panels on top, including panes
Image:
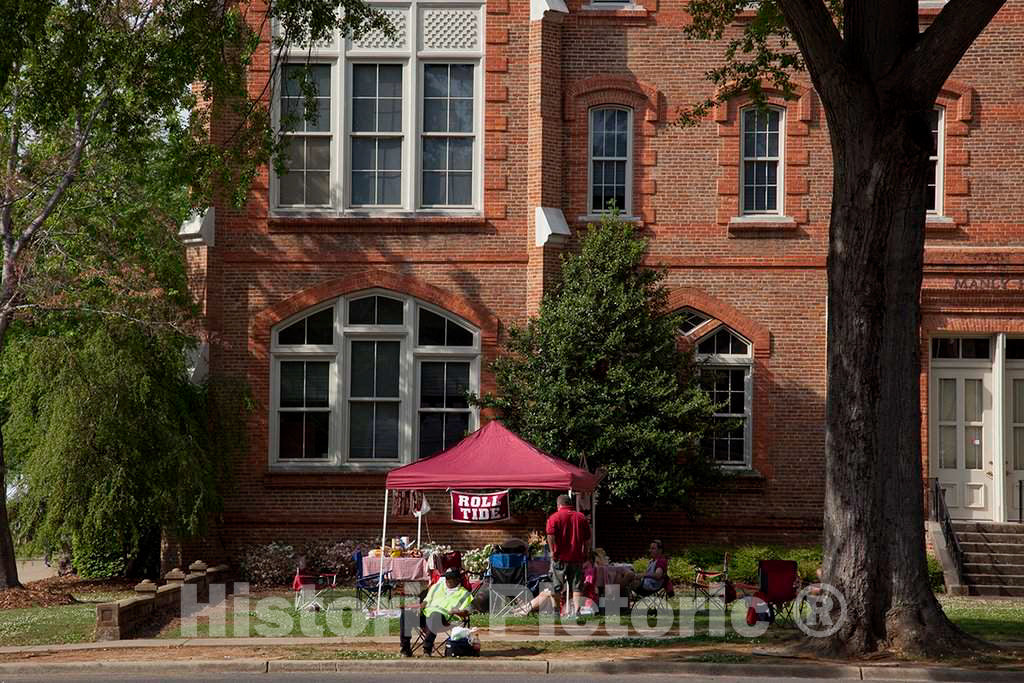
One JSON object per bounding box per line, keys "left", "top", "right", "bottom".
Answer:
{"left": 270, "top": 0, "right": 485, "bottom": 216}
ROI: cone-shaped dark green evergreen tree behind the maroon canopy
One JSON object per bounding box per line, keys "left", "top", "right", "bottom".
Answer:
{"left": 482, "top": 215, "right": 715, "bottom": 507}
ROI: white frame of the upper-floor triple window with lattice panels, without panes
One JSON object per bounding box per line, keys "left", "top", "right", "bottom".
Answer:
{"left": 268, "top": 0, "right": 486, "bottom": 217}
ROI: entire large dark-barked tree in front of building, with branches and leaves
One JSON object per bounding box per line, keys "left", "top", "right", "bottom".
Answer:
{"left": 683, "top": 0, "right": 1004, "bottom": 655}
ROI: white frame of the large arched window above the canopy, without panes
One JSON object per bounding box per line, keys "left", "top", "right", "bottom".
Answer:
{"left": 267, "top": 288, "right": 481, "bottom": 471}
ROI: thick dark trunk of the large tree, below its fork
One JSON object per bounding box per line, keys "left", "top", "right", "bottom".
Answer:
{"left": 824, "top": 102, "right": 976, "bottom": 655}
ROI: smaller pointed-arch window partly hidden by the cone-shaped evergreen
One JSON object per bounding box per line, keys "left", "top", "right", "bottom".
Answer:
{"left": 696, "top": 326, "right": 754, "bottom": 469}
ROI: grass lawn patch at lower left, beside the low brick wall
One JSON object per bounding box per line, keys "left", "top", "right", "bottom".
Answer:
{"left": 0, "top": 592, "right": 134, "bottom": 645}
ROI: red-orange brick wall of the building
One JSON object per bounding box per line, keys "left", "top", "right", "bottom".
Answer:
{"left": 182, "top": 0, "right": 1024, "bottom": 561}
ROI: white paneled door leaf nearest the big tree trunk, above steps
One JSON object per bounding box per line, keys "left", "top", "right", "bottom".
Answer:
{"left": 929, "top": 369, "right": 993, "bottom": 520}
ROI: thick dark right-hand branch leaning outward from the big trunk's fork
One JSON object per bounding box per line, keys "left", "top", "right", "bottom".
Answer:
{"left": 886, "top": 0, "right": 1006, "bottom": 105}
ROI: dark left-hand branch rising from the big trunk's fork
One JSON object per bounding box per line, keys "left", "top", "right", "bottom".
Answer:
{"left": 777, "top": 0, "right": 844, "bottom": 96}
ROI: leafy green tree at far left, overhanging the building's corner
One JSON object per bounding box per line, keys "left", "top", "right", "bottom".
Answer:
{"left": 0, "top": 0, "right": 391, "bottom": 590}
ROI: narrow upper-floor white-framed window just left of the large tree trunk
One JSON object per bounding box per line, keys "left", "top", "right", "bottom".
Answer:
{"left": 739, "top": 106, "right": 785, "bottom": 215}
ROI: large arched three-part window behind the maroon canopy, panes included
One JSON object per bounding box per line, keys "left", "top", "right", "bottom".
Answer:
{"left": 270, "top": 290, "right": 480, "bottom": 468}
